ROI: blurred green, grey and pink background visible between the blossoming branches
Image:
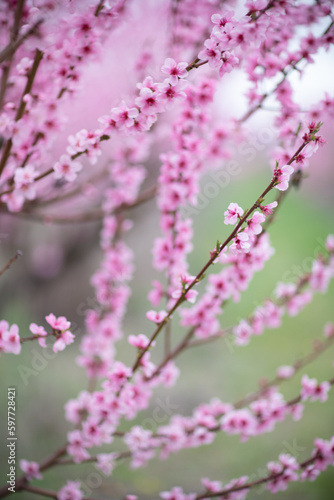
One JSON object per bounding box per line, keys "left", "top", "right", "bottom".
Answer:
{"left": 0, "top": 2, "right": 334, "bottom": 500}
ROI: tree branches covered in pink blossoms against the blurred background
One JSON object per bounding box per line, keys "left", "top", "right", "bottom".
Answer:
{"left": 0, "top": 0, "right": 334, "bottom": 500}
